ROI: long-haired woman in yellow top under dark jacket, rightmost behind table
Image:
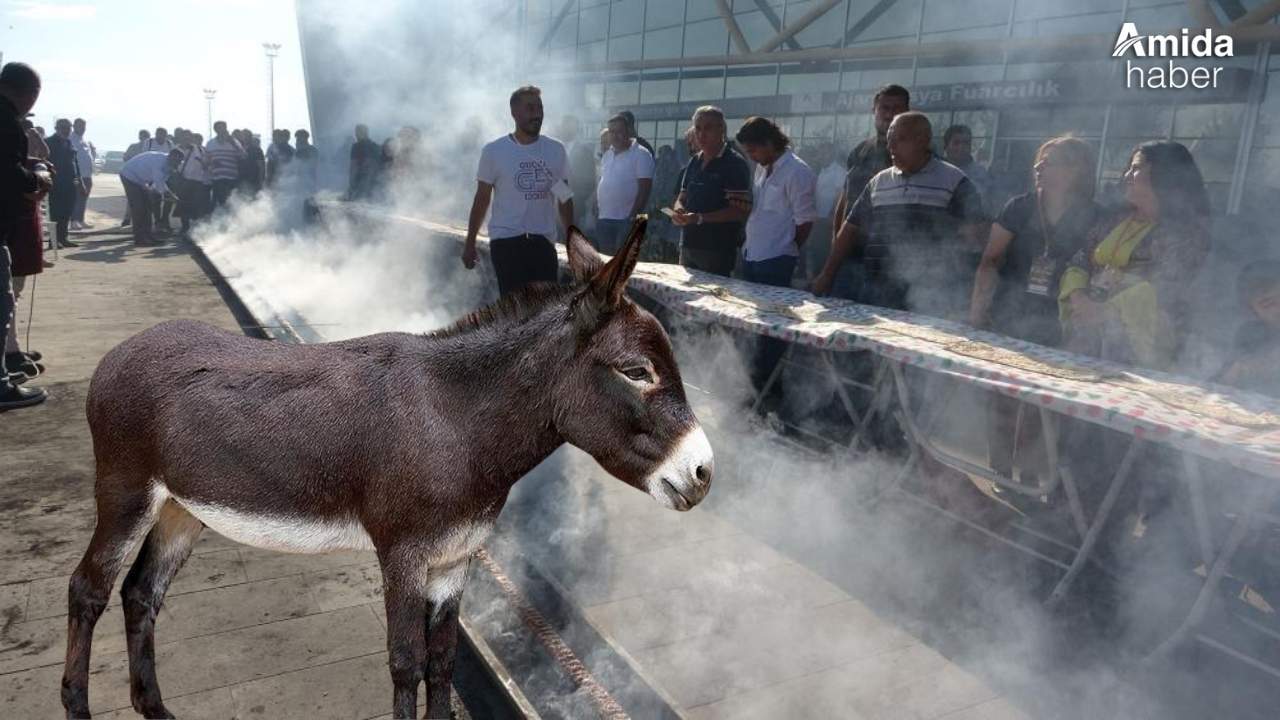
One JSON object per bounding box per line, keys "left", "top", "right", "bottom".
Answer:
{"left": 1059, "top": 141, "right": 1210, "bottom": 369}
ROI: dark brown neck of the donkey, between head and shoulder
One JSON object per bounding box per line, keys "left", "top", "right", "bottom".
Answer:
{"left": 414, "top": 297, "right": 573, "bottom": 491}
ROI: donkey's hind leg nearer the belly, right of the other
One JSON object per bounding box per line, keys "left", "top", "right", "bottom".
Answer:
{"left": 120, "top": 500, "right": 205, "bottom": 717}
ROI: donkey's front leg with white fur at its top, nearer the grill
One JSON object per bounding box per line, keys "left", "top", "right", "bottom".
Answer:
{"left": 425, "top": 560, "right": 471, "bottom": 720}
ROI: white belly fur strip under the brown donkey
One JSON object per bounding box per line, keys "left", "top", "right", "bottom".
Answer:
{"left": 173, "top": 496, "right": 374, "bottom": 553}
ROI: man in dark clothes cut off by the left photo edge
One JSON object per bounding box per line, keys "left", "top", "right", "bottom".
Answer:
{"left": 0, "top": 63, "right": 52, "bottom": 411}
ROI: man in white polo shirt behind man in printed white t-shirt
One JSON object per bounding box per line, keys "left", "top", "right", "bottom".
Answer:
{"left": 595, "top": 114, "right": 654, "bottom": 255}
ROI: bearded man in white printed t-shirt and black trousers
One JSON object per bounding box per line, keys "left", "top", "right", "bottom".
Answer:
{"left": 462, "top": 86, "right": 573, "bottom": 295}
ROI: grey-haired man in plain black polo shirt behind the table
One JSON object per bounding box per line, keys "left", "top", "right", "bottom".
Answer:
{"left": 671, "top": 105, "right": 751, "bottom": 277}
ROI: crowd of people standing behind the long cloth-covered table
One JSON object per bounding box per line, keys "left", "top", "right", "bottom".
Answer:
{"left": 445, "top": 85, "right": 1280, "bottom": 404}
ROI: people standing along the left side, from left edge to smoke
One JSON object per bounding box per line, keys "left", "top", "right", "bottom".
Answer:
{"left": 0, "top": 63, "right": 319, "bottom": 411}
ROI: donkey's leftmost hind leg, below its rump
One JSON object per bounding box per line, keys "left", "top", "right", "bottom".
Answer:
{"left": 61, "top": 477, "right": 163, "bottom": 717}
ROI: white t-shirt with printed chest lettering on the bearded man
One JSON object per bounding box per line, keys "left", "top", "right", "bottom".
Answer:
{"left": 476, "top": 135, "right": 568, "bottom": 240}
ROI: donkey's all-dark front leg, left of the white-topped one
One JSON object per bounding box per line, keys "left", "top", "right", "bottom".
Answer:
{"left": 381, "top": 556, "right": 428, "bottom": 717}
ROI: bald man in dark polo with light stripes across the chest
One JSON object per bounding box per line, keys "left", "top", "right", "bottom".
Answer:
{"left": 813, "top": 113, "right": 986, "bottom": 318}
